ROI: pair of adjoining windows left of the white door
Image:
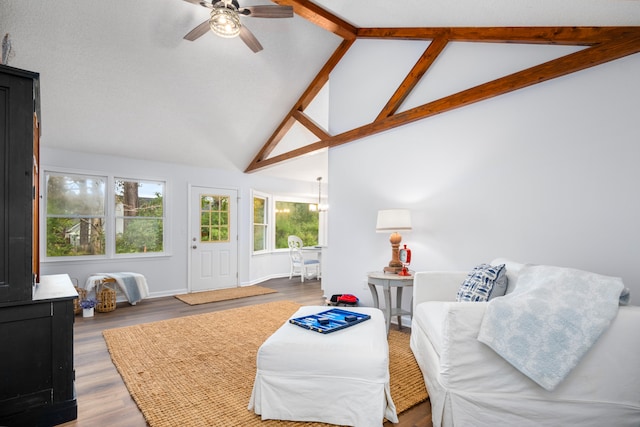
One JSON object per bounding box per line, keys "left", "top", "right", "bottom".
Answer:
{"left": 44, "top": 171, "right": 165, "bottom": 259}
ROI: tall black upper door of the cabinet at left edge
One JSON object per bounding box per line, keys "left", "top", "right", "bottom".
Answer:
{"left": 0, "top": 66, "right": 37, "bottom": 304}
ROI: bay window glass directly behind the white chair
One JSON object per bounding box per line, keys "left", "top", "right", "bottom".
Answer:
{"left": 275, "top": 200, "right": 319, "bottom": 249}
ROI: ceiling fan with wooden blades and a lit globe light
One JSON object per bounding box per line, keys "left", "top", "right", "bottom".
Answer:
{"left": 184, "top": 0, "right": 293, "bottom": 52}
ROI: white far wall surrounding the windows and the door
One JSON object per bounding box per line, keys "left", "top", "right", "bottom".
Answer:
{"left": 41, "top": 149, "right": 318, "bottom": 297}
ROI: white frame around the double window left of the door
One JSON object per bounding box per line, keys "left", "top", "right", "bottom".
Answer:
{"left": 38, "top": 165, "right": 171, "bottom": 263}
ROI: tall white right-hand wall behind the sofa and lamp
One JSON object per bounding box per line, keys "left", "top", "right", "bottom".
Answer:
{"left": 323, "top": 42, "right": 640, "bottom": 306}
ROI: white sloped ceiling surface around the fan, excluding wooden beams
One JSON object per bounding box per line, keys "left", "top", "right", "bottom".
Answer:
{"left": 0, "top": 0, "right": 640, "bottom": 182}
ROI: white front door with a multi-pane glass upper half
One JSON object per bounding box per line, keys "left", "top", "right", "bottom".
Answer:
{"left": 189, "top": 186, "right": 238, "bottom": 292}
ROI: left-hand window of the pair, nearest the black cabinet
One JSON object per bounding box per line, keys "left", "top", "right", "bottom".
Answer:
{"left": 45, "top": 172, "right": 106, "bottom": 257}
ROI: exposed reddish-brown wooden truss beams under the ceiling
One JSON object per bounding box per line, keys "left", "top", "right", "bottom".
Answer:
{"left": 245, "top": 0, "right": 640, "bottom": 172}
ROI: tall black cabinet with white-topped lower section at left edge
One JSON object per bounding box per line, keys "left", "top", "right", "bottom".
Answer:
{"left": 0, "top": 65, "right": 77, "bottom": 427}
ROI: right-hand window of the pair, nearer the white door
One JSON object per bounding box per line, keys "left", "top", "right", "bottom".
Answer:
{"left": 114, "top": 178, "right": 164, "bottom": 254}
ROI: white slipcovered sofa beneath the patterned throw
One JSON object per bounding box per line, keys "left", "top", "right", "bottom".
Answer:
{"left": 411, "top": 259, "right": 640, "bottom": 427}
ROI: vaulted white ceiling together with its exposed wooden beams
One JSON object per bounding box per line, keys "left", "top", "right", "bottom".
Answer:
{"left": 0, "top": 0, "right": 640, "bottom": 181}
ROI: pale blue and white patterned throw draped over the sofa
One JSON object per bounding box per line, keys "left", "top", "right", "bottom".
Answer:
{"left": 478, "top": 265, "right": 624, "bottom": 391}
